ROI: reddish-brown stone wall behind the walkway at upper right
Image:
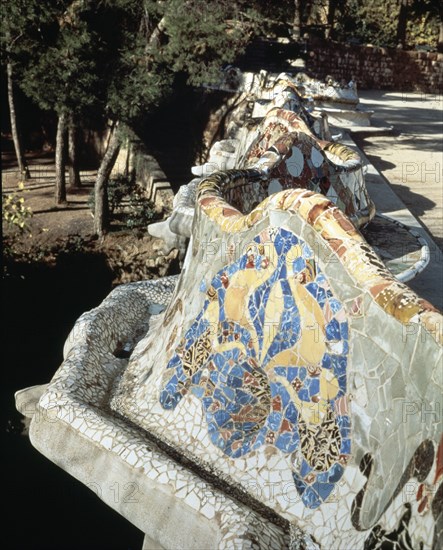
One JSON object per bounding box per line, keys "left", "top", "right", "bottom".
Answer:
{"left": 306, "top": 43, "right": 443, "bottom": 94}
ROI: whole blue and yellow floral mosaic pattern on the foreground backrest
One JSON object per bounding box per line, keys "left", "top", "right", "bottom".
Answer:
{"left": 160, "top": 228, "right": 351, "bottom": 508}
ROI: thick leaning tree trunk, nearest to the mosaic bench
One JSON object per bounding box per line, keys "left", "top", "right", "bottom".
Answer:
{"left": 94, "top": 124, "right": 120, "bottom": 237}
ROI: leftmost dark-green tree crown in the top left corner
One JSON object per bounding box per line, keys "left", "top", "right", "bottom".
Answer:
{"left": 8, "top": 0, "right": 100, "bottom": 114}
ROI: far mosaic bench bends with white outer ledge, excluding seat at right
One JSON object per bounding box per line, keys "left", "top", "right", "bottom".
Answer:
{"left": 148, "top": 73, "right": 382, "bottom": 282}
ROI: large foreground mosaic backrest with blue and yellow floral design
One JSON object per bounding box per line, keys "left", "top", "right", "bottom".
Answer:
{"left": 112, "top": 170, "right": 443, "bottom": 548}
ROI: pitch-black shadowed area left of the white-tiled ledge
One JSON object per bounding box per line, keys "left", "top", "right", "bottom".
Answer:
{"left": 1, "top": 254, "right": 143, "bottom": 550}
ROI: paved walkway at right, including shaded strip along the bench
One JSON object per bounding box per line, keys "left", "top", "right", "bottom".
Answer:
{"left": 352, "top": 91, "right": 443, "bottom": 309}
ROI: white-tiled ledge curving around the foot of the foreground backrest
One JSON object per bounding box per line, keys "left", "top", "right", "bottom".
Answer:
{"left": 16, "top": 276, "right": 290, "bottom": 550}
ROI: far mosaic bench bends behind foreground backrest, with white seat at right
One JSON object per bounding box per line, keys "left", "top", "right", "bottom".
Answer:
{"left": 153, "top": 71, "right": 430, "bottom": 282}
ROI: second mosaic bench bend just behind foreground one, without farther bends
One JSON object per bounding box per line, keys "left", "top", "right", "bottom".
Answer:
{"left": 148, "top": 107, "right": 375, "bottom": 264}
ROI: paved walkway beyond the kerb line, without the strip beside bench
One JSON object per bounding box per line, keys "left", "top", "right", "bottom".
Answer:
{"left": 359, "top": 91, "right": 443, "bottom": 250}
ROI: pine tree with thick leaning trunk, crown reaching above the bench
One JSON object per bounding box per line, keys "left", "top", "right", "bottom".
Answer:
{"left": 94, "top": 0, "right": 255, "bottom": 235}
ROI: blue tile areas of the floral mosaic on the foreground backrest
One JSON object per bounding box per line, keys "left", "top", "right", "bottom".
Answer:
{"left": 160, "top": 226, "right": 350, "bottom": 508}
